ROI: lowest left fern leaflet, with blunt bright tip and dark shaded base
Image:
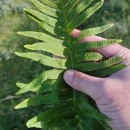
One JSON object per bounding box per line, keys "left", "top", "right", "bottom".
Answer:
{"left": 27, "top": 102, "right": 75, "bottom": 128}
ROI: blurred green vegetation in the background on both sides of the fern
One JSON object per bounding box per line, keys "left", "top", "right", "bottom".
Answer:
{"left": 0, "top": 0, "right": 130, "bottom": 130}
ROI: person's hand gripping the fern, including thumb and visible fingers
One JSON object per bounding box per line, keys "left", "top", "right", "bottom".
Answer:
{"left": 64, "top": 29, "right": 130, "bottom": 130}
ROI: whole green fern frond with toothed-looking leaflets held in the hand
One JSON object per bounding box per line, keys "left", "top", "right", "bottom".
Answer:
{"left": 15, "top": 0, "right": 125, "bottom": 130}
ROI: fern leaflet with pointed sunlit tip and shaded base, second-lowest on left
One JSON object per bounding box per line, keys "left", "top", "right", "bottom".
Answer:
{"left": 15, "top": 89, "right": 72, "bottom": 109}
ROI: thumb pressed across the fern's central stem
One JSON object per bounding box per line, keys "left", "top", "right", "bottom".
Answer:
{"left": 64, "top": 70, "right": 105, "bottom": 100}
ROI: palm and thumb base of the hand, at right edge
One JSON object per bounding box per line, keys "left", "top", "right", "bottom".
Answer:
{"left": 96, "top": 53, "right": 130, "bottom": 130}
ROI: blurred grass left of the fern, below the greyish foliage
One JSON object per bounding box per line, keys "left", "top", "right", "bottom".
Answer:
{"left": 0, "top": 1, "right": 43, "bottom": 130}
